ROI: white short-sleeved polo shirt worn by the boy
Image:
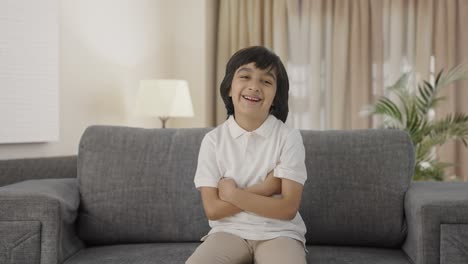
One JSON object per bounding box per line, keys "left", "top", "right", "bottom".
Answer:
{"left": 194, "top": 115, "right": 307, "bottom": 245}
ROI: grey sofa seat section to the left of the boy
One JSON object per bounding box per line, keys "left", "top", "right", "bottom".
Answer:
{"left": 64, "top": 243, "right": 199, "bottom": 264}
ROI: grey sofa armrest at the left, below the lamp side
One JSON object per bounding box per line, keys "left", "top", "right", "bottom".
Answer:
{"left": 0, "top": 179, "right": 83, "bottom": 264}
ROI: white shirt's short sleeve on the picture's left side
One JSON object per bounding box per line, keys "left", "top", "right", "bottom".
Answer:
{"left": 194, "top": 133, "right": 221, "bottom": 188}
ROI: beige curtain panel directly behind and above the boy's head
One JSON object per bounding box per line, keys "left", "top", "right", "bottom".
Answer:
{"left": 215, "top": 0, "right": 288, "bottom": 125}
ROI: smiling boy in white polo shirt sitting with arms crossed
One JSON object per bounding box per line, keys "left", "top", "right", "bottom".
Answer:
{"left": 186, "top": 46, "right": 307, "bottom": 264}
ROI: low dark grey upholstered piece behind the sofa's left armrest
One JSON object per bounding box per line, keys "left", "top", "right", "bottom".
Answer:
{"left": 0, "top": 155, "right": 77, "bottom": 186}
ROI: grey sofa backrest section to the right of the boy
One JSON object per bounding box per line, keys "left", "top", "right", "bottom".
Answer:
{"left": 300, "top": 130, "right": 414, "bottom": 247}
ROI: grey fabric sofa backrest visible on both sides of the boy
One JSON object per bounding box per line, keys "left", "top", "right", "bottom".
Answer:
{"left": 78, "top": 126, "right": 414, "bottom": 247}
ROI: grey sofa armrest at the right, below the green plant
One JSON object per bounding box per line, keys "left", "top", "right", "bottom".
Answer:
{"left": 403, "top": 182, "right": 468, "bottom": 264}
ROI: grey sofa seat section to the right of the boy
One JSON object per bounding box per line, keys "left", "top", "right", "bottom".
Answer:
{"left": 307, "top": 246, "right": 411, "bottom": 264}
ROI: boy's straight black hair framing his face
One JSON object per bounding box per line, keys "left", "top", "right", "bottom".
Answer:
{"left": 220, "top": 46, "right": 289, "bottom": 123}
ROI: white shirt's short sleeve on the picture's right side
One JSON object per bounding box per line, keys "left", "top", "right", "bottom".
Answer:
{"left": 274, "top": 130, "right": 307, "bottom": 185}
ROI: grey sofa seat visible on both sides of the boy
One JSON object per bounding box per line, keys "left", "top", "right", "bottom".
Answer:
{"left": 64, "top": 243, "right": 411, "bottom": 264}
